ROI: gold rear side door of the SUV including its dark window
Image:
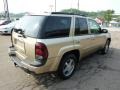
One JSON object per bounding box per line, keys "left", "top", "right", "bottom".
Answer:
{"left": 74, "top": 17, "right": 92, "bottom": 56}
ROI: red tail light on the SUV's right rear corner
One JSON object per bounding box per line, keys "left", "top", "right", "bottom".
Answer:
{"left": 35, "top": 43, "right": 48, "bottom": 66}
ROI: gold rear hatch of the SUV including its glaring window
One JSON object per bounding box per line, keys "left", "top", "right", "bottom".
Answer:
{"left": 12, "top": 16, "right": 44, "bottom": 64}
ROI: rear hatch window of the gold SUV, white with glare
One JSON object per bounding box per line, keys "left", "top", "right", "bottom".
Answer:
{"left": 15, "top": 16, "right": 45, "bottom": 38}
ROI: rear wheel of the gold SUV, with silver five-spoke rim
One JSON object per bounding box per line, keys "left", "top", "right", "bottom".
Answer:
{"left": 58, "top": 54, "right": 77, "bottom": 80}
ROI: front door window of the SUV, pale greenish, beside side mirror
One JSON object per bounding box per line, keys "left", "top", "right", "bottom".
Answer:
{"left": 88, "top": 19, "right": 100, "bottom": 34}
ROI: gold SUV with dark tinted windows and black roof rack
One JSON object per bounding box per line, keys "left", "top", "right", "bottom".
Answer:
{"left": 9, "top": 13, "right": 111, "bottom": 79}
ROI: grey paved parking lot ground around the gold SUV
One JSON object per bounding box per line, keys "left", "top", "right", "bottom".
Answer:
{"left": 0, "top": 30, "right": 120, "bottom": 90}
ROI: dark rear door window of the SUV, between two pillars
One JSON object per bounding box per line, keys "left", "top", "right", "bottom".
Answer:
{"left": 75, "top": 18, "right": 88, "bottom": 36}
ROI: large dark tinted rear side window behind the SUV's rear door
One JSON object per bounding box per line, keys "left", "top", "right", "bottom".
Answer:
{"left": 44, "top": 16, "right": 71, "bottom": 38}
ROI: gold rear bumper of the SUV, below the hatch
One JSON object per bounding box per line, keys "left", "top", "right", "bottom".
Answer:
{"left": 8, "top": 47, "right": 52, "bottom": 74}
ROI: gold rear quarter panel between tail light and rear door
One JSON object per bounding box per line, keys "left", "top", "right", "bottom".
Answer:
{"left": 37, "top": 37, "right": 74, "bottom": 71}
